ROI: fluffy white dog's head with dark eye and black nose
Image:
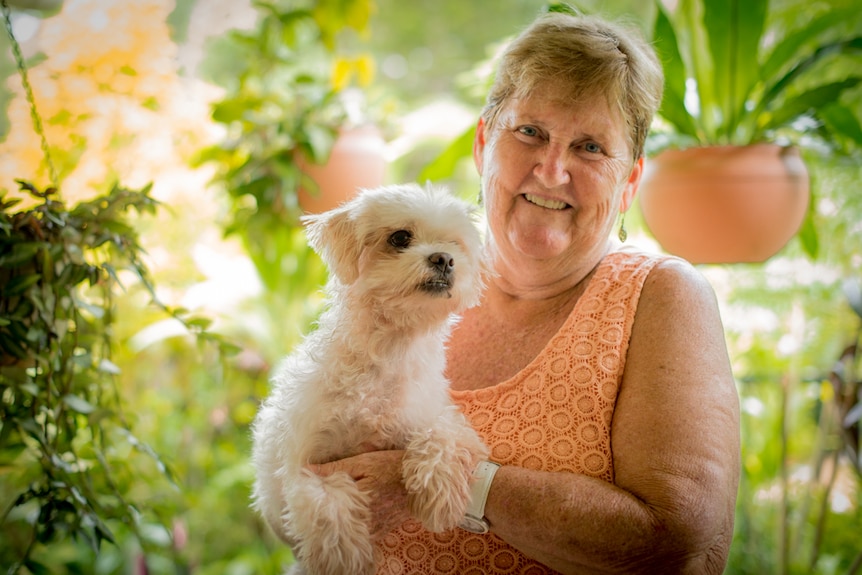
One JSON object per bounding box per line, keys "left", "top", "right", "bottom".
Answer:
{"left": 303, "top": 184, "right": 484, "bottom": 321}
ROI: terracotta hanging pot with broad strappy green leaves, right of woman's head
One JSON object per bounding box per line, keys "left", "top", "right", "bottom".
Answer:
{"left": 639, "top": 0, "right": 862, "bottom": 263}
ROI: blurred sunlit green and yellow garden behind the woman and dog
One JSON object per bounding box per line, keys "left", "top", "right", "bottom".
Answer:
{"left": 0, "top": 0, "right": 862, "bottom": 575}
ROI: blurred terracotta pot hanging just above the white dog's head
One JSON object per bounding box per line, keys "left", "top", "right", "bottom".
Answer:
{"left": 297, "top": 125, "right": 386, "bottom": 214}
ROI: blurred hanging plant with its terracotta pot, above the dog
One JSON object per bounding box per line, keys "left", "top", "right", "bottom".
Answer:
{"left": 202, "top": 0, "right": 385, "bottom": 297}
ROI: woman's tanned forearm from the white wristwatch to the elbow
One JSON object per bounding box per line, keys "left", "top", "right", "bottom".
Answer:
{"left": 485, "top": 466, "right": 723, "bottom": 574}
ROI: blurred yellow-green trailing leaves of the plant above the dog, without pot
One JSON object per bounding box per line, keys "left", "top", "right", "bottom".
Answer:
{"left": 201, "top": 0, "right": 373, "bottom": 291}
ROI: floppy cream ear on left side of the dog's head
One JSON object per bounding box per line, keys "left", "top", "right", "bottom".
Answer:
{"left": 300, "top": 207, "right": 362, "bottom": 285}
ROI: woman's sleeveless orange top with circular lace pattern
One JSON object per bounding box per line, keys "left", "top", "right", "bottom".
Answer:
{"left": 378, "top": 251, "right": 660, "bottom": 575}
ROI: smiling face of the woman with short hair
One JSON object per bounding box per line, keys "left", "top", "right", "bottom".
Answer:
{"left": 473, "top": 91, "right": 643, "bottom": 265}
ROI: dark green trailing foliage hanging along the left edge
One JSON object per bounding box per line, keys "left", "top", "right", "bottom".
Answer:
{"left": 0, "top": 181, "right": 176, "bottom": 573}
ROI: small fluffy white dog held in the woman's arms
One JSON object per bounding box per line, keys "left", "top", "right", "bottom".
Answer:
{"left": 253, "top": 184, "right": 487, "bottom": 575}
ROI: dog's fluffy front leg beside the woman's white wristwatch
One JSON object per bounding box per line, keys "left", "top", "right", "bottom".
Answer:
{"left": 402, "top": 407, "right": 488, "bottom": 532}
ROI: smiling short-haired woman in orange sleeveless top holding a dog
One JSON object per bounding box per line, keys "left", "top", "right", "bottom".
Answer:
{"left": 315, "top": 10, "right": 739, "bottom": 574}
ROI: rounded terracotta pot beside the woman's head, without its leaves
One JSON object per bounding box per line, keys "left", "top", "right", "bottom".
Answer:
{"left": 639, "top": 144, "right": 809, "bottom": 263}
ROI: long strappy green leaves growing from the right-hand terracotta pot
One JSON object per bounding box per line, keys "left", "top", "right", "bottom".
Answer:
{"left": 653, "top": 0, "right": 862, "bottom": 151}
